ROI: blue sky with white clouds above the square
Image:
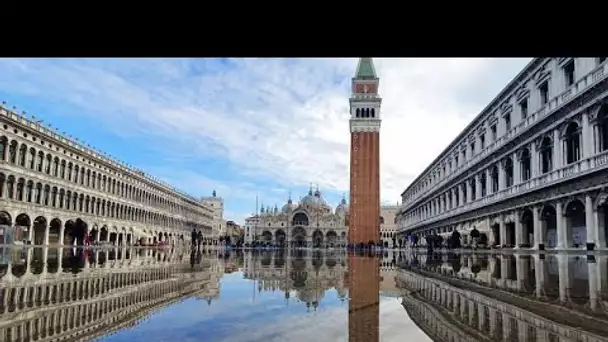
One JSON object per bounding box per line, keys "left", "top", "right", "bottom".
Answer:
{"left": 0, "top": 58, "right": 530, "bottom": 223}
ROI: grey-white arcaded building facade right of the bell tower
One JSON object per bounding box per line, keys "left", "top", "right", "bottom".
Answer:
{"left": 398, "top": 57, "right": 608, "bottom": 249}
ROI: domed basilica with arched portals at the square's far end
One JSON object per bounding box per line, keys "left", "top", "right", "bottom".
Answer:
{"left": 245, "top": 186, "right": 348, "bottom": 247}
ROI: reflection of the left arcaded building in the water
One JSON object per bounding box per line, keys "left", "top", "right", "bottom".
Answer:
{"left": 0, "top": 247, "right": 223, "bottom": 342}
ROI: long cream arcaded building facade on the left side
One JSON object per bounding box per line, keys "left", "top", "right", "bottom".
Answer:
{"left": 0, "top": 106, "right": 213, "bottom": 245}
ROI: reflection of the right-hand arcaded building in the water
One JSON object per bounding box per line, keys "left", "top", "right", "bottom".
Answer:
{"left": 396, "top": 254, "right": 608, "bottom": 341}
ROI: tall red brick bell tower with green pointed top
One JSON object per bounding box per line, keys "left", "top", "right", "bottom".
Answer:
{"left": 348, "top": 58, "right": 382, "bottom": 244}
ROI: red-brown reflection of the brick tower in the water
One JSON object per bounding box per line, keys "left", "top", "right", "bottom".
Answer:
{"left": 348, "top": 251, "right": 380, "bottom": 342}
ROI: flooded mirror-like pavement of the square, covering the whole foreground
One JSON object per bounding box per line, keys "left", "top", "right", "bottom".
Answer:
{"left": 0, "top": 247, "right": 608, "bottom": 342}
